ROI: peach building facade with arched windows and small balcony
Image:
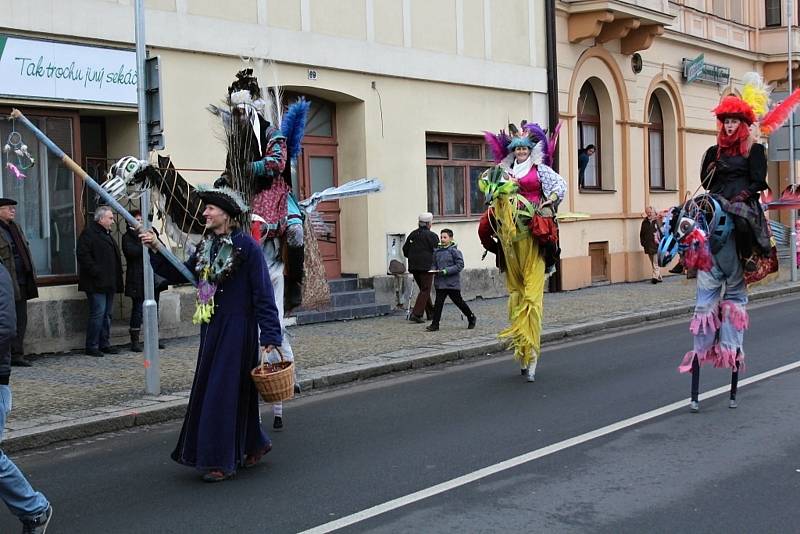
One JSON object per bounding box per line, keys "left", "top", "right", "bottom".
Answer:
{"left": 555, "top": 0, "right": 797, "bottom": 289}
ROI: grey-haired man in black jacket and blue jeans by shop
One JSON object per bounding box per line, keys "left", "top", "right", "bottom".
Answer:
{"left": 77, "top": 206, "right": 122, "bottom": 357}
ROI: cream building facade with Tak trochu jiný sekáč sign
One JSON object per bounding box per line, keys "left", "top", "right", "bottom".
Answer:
{"left": 0, "top": 0, "right": 548, "bottom": 356}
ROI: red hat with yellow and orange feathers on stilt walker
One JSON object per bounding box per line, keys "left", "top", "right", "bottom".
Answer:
{"left": 714, "top": 72, "right": 800, "bottom": 135}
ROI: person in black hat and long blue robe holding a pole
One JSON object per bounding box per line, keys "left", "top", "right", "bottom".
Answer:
{"left": 140, "top": 187, "right": 283, "bottom": 482}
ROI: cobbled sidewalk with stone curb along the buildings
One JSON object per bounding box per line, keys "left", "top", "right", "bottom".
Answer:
{"left": 3, "top": 266, "right": 800, "bottom": 451}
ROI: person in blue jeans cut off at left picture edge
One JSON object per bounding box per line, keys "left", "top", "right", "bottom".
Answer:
{"left": 0, "top": 263, "right": 53, "bottom": 534}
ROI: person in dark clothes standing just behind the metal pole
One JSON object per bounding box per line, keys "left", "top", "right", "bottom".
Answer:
{"left": 122, "top": 210, "right": 167, "bottom": 352}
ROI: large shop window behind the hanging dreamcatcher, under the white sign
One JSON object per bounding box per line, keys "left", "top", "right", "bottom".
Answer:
{"left": 0, "top": 113, "right": 77, "bottom": 282}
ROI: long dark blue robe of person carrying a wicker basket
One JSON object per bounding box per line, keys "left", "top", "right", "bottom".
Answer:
{"left": 151, "top": 230, "right": 282, "bottom": 473}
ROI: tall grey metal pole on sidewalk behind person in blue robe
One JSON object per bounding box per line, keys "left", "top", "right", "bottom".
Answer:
{"left": 134, "top": 0, "right": 161, "bottom": 395}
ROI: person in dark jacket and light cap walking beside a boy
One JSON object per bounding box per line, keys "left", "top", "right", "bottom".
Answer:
{"left": 403, "top": 213, "right": 439, "bottom": 323}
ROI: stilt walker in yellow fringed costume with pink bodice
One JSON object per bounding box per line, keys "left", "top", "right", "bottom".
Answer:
{"left": 478, "top": 121, "right": 566, "bottom": 382}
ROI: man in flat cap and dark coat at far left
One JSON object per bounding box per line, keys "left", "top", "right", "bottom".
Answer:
{"left": 0, "top": 198, "right": 39, "bottom": 367}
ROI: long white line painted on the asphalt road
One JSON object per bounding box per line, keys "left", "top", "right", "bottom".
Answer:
{"left": 300, "top": 360, "right": 800, "bottom": 534}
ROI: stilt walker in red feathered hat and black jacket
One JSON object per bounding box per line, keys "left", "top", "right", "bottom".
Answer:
{"left": 658, "top": 73, "right": 800, "bottom": 412}
